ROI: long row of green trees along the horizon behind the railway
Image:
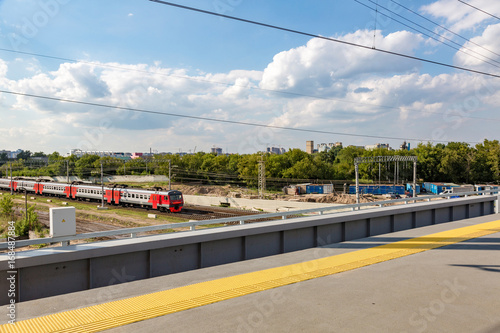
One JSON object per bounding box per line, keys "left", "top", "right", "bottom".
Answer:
{"left": 0, "top": 140, "right": 500, "bottom": 187}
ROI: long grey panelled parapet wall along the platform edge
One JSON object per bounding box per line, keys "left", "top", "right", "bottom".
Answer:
{"left": 0, "top": 196, "right": 496, "bottom": 304}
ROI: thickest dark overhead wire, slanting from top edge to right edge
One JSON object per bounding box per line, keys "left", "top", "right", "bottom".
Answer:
{"left": 149, "top": 0, "right": 500, "bottom": 78}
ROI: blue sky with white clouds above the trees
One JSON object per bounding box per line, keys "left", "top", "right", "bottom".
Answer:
{"left": 0, "top": 0, "right": 500, "bottom": 154}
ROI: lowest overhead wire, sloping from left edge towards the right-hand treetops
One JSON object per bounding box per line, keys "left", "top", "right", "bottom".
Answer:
{"left": 0, "top": 90, "right": 479, "bottom": 143}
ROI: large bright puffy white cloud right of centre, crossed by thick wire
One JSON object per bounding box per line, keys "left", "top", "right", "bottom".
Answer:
{"left": 261, "top": 30, "right": 423, "bottom": 96}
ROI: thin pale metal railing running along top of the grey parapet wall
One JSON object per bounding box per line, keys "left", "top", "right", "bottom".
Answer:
{"left": 0, "top": 189, "right": 500, "bottom": 250}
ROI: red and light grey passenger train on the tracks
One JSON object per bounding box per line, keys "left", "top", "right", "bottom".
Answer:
{"left": 0, "top": 178, "right": 184, "bottom": 213}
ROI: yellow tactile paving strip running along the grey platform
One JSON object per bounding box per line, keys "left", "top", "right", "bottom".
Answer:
{"left": 0, "top": 220, "right": 500, "bottom": 333}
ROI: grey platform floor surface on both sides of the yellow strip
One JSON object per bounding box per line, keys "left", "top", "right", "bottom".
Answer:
{"left": 0, "top": 215, "right": 500, "bottom": 333}
